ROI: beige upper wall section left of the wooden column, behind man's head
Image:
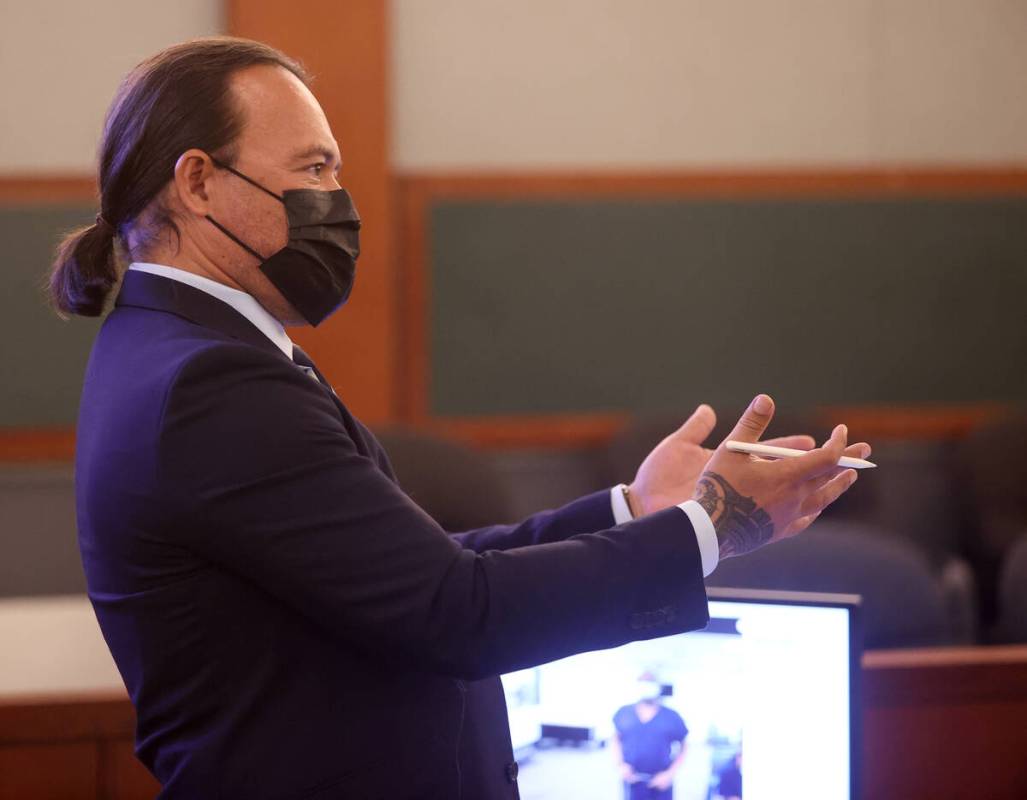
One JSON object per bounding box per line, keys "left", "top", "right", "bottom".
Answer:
{"left": 0, "top": 0, "right": 223, "bottom": 174}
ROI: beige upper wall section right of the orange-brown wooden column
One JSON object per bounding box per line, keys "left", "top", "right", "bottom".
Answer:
{"left": 391, "top": 0, "right": 1027, "bottom": 170}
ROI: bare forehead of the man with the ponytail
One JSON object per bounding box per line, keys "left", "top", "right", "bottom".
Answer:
{"left": 229, "top": 65, "right": 336, "bottom": 161}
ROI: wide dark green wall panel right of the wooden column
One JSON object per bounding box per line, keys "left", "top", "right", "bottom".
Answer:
{"left": 429, "top": 197, "right": 1027, "bottom": 416}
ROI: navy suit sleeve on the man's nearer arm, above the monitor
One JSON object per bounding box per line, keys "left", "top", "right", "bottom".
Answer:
{"left": 158, "top": 344, "right": 709, "bottom": 680}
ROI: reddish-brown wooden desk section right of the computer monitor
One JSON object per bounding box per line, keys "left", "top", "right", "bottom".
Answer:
{"left": 863, "top": 646, "right": 1027, "bottom": 800}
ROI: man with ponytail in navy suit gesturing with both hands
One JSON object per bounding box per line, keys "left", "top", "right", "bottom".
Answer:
{"left": 51, "top": 38, "right": 869, "bottom": 800}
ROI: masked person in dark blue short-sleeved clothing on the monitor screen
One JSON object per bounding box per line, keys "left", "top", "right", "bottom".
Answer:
{"left": 612, "top": 673, "right": 688, "bottom": 800}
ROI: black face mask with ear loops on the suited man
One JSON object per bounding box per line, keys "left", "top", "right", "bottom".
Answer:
{"left": 206, "top": 160, "right": 360, "bottom": 326}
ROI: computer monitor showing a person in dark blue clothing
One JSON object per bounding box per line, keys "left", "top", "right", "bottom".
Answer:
{"left": 503, "top": 588, "right": 862, "bottom": 800}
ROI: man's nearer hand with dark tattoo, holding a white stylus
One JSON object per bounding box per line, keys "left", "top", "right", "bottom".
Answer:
{"left": 695, "top": 394, "right": 870, "bottom": 559}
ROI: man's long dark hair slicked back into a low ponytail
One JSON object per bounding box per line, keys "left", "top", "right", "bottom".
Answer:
{"left": 49, "top": 36, "right": 309, "bottom": 316}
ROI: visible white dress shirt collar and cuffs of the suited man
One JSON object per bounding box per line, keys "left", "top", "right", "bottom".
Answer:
{"left": 128, "top": 261, "right": 720, "bottom": 577}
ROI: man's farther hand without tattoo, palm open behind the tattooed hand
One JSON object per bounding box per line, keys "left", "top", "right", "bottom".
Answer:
{"left": 627, "top": 405, "right": 869, "bottom": 518}
